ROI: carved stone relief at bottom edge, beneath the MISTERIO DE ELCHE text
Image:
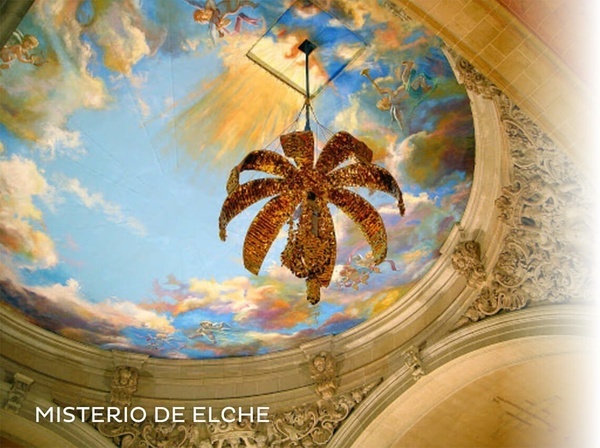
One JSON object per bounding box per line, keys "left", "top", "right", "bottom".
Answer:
{"left": 94, "top": 380, "right": 381, "bottom": 448}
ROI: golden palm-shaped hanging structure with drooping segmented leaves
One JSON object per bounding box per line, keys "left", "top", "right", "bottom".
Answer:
{"left": 219, "top": 131, "right": 404, "bottom": 304}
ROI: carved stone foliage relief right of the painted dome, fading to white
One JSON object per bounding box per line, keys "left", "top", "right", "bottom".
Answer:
{"left": 455, "top": 57, "right": 594, "bottom": 325}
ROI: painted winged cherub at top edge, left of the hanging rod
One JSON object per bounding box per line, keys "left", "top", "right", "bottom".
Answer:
{"left": 185, "top": 0, "right": 260, "bottom": 37}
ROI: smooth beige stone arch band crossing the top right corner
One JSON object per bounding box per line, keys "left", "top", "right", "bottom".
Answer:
{"left": 395, "top": 0, "right": 597, "bottom": 169}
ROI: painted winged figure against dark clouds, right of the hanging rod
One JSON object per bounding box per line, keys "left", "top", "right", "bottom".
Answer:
{"left": 361, "top": 61, "right": 435, "bottom": 133}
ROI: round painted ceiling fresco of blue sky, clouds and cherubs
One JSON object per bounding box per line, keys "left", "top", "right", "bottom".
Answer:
{"left": 0, "top": 0, "right": 474, "bottom": 358}
